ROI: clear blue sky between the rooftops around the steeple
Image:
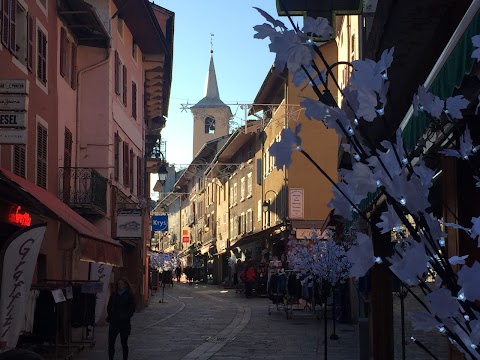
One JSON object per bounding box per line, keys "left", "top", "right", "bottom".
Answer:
{"left": 154, "top": 0, "right": 287, "bottom": 164}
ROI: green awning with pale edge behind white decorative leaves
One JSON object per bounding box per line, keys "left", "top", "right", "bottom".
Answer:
{"left": 400, "top": 0, "right": 480, "bottom": 150}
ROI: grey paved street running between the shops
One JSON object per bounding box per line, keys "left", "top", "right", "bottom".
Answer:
{"left": 76, "top": 283, "right": 358, "bottom": 360}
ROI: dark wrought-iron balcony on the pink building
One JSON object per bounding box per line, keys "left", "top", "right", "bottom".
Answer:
{"left": 58, "top": 168, "right": 107, "bottom": 217}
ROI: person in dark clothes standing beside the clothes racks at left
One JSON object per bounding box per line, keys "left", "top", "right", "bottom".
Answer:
{"left": 107, "top": 278, "right": 135, "bottom": 360}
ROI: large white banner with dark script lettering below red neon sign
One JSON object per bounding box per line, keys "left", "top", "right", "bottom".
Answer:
{"left": 0, "top": 224, "right": 47, "bottom": 350}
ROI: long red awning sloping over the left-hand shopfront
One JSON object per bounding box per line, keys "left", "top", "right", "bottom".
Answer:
{"left": 0, "top": 168, "right": 123, "bottom": 266}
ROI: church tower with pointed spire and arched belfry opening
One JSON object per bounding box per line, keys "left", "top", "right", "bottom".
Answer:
{"left": 190, "top": 50, "right": 232, "bottom": 158}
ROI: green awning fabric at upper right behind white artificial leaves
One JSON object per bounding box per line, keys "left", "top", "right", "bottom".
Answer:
{"left": 402, "top": 5, "right": 480, "bottom": 150}
